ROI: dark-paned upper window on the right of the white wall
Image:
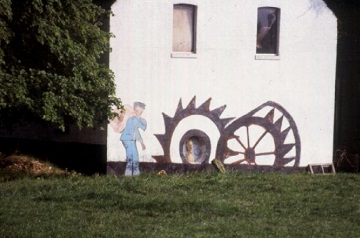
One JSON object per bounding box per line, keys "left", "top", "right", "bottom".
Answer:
{"left": 256, "top": 7, "right": 280, "bottom": 55}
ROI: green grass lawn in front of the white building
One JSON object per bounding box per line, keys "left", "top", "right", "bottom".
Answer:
{"left": 0, "top": 171, "right": 360, "bottom": 237}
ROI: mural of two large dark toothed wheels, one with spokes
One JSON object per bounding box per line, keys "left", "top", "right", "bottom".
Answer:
{"left": 153, "top": 97, "right": 301, "bottom": 167}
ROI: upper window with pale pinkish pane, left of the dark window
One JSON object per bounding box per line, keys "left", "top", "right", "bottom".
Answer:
{"left": 173, "top": 4, "right": 196, "bottom": 53}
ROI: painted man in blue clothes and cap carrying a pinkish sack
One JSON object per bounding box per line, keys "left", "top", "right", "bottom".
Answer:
{"left": 110, "top": 102, "right": 147, "bottom": 176}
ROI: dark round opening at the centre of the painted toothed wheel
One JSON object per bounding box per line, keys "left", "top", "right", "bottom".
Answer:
{"left": 179, "top": 130, "right": 211, "bottom": 164}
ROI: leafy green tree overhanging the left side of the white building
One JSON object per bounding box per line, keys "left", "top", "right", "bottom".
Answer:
{"left": 0, "top": 0, "right": 122, "bottom": 130}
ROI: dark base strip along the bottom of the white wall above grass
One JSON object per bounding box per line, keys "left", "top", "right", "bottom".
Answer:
{"left": 106, "top": 162, "right": 308, "bottom": 176}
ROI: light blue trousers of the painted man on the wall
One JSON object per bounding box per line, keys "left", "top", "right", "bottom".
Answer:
{"left": 122, "top": 140, "right": 140, "bottom": 176}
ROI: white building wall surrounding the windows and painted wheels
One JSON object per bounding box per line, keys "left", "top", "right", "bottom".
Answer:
{"left": 107, "top": 0, "right": 337, "bottom": 166}
